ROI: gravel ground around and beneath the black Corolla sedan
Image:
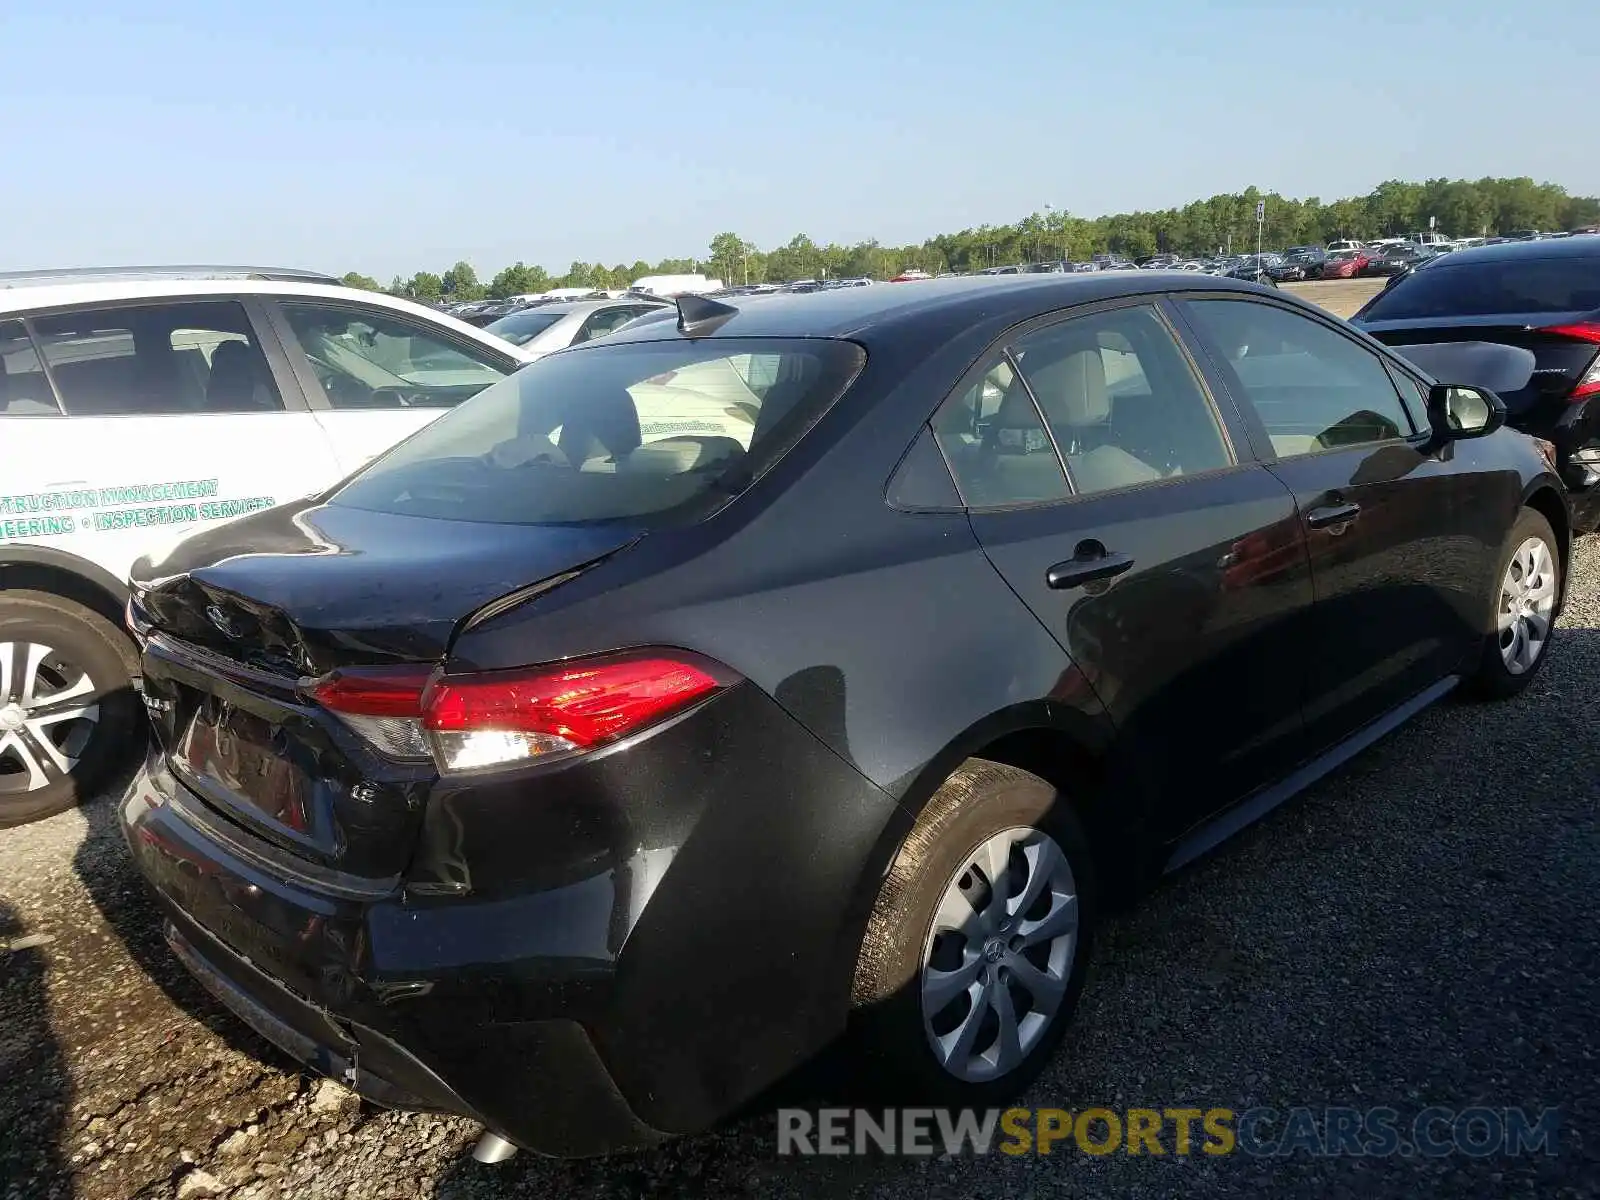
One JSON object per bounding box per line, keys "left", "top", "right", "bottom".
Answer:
{"left": 0, "top": 539, "right": 1600, "bottom": 1200}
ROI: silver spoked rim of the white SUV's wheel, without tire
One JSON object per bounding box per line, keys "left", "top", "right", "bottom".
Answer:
{"left": 0, "top": 642, "right": 99, "bottom": 792}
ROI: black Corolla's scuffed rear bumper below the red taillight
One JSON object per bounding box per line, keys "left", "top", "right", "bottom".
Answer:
{"left": 120, "top": 685, "right": 906, "bottom": 1157}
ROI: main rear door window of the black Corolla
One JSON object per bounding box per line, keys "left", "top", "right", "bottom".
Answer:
{"left": 1011, "top": 306, "right": 1232, "bottom": 493}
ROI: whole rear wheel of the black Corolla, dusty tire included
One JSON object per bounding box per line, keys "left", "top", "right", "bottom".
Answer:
{"left": 854, "top": 758, "right": 1094, "bottom": 1107}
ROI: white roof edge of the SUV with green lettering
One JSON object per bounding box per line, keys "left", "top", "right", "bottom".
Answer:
{"left": 0, "top": 278, "right": 526, "bottom": 358}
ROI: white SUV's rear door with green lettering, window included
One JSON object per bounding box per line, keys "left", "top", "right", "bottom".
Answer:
{"left": 5, "top": 296, "right": 338, "bottom": 578}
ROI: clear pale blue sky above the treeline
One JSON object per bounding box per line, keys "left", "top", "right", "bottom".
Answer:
{"left": 0, "top": 0, "right": 1600, "bottom": 280}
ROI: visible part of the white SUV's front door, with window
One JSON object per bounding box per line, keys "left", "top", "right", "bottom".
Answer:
{"left": 264, "top": 296, "right": 520, "bottom": 474}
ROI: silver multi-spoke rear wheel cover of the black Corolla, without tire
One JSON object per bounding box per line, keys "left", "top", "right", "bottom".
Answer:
{"left": 922, "top": 827, "right": 1078, "bottom": 1083}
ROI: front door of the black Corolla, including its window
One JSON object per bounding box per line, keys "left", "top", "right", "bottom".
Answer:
{"left": 1181, "top": 296, "right": 1515, "bottom": 749}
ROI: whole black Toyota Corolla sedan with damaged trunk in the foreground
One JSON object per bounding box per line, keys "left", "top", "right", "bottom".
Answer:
{"left": 122, "top": 272, "right": 1568, "bottom": 1157}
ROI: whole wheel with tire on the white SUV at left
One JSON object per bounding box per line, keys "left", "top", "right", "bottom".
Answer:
{"left": 0, "top": 592, "right": 144, "bottom": 827}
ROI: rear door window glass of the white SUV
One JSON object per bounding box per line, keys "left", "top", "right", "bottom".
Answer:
{"left": 34, "top": 301, "right": 283, "bottom": 416}
